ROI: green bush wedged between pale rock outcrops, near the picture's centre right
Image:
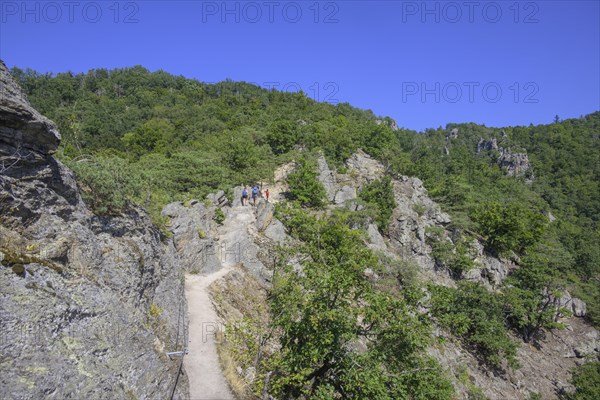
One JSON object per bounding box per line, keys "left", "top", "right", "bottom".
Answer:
{"left": 358, "top": 177, "right": 396, "bottom": 232}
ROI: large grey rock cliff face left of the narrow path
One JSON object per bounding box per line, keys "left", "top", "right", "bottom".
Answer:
{"left": 0, "top": 62, "right": 186, "bottom": 399}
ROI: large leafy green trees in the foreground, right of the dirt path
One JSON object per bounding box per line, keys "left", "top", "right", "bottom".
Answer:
{"left": 272, "top": 207, "right": 452, "bottom": 399}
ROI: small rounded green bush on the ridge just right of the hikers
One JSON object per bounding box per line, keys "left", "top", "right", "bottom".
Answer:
{"left": 288, "top": 158, "right": 327, "bottom": 207}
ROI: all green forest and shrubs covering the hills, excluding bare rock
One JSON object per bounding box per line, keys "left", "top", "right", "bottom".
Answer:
{"left": 11, "top": 66, "right": 600, "bottom": 399}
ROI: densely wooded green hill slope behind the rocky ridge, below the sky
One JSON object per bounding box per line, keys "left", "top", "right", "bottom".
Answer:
{"left": 11, "top": 66, "right": 600, "bottom": 332}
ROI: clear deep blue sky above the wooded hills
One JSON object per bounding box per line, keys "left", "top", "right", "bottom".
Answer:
{"left": 0, "top": 0, "right": 600, "bottom": 130}
